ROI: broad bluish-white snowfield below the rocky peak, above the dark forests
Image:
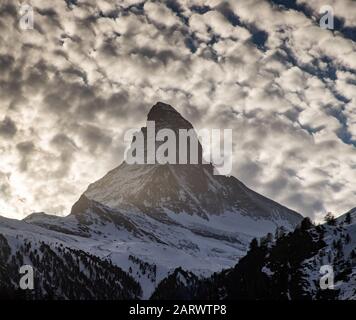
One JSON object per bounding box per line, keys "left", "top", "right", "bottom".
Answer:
{"left": 21, "top": 196, "right": 300, "bottom": 298}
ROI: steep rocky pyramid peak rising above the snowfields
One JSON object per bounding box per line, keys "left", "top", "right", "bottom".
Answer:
{"left": 85, "top": 102, "right": 301, "bottom": 224}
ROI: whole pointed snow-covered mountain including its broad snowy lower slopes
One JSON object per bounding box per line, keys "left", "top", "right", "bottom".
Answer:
{"left": 0, "top": 103, "right": 302, "bottom": 298}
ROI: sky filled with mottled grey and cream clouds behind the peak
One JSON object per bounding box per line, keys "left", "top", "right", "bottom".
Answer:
{"left": 0, "top": 0, "right": 356, "bottom": 219}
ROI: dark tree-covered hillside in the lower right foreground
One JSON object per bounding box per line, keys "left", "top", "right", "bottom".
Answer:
{"left": 152, "top": 209, "right": 356, "bottom": 300}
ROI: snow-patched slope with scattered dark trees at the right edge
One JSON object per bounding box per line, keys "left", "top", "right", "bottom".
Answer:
{"left": 250, "top": 209, "right": 356, "bottom": 300}
